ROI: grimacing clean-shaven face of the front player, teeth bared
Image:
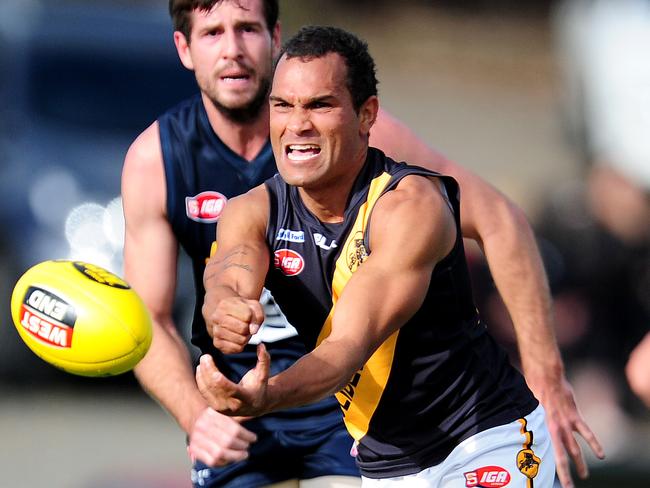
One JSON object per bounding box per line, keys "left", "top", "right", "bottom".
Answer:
{"left": 269, "top": 53, "right": 377, "bottom": 191}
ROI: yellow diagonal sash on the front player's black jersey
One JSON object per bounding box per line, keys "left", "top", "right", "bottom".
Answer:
{"left": 316, "top": 173, "right": 399, "bottom": 441}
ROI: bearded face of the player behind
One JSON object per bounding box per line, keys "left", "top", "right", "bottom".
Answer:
{"left": 174, "top": 0, "right": 280, "bottom": 120}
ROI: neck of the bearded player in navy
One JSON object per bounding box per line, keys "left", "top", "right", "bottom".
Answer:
{"left": 201, "top": 94, "right": 269, "bottom": 161}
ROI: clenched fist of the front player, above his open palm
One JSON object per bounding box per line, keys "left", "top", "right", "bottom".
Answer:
{"left": 203, "top": 296, "right": 264, "bottom": 354}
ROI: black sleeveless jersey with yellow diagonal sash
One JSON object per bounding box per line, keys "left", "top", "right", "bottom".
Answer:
{"left": 266, "top": 148, "right": 538, "bottom": 478}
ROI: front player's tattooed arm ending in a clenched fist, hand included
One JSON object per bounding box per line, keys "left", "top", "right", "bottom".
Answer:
{"left": 203, "top": 185, "right": 269, "bottom": 354}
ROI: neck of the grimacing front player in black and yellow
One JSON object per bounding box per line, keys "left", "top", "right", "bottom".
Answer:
{"left": 298, "top": 147, "right": 368, "bottom": 224}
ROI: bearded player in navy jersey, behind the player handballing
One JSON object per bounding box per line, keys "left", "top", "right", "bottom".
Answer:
{"left": 122, "top": 0, "right": 604, "bottom": 486}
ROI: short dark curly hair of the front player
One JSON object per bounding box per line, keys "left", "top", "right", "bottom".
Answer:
{"left": 280, "top": 25, "right": 378, "bottom": 111}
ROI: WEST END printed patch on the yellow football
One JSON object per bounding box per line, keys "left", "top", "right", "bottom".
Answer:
{"left": 20, "top": 286, "right": 77, "bottom": 348}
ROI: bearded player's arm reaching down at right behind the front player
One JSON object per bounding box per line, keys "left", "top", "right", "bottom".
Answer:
{"left": 370, "top": 111, "right": 604, "bottom": 488}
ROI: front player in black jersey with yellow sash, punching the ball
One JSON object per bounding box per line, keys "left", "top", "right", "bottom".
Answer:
{"left": 196, "top": 27, "right": 604, "bottom": 487}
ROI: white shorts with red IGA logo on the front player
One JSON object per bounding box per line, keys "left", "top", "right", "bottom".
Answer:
{"left": 361, "top": 405, "right": 559, "bottom": 488}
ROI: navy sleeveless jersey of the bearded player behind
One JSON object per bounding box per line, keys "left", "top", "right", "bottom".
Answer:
{"left": 158, "top": 96, "right": 341, "bottom": 431}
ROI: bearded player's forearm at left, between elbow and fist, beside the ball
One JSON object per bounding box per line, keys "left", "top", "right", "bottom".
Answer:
{"left": 134, "top": 324, "right": 207, "bottom": 434}
